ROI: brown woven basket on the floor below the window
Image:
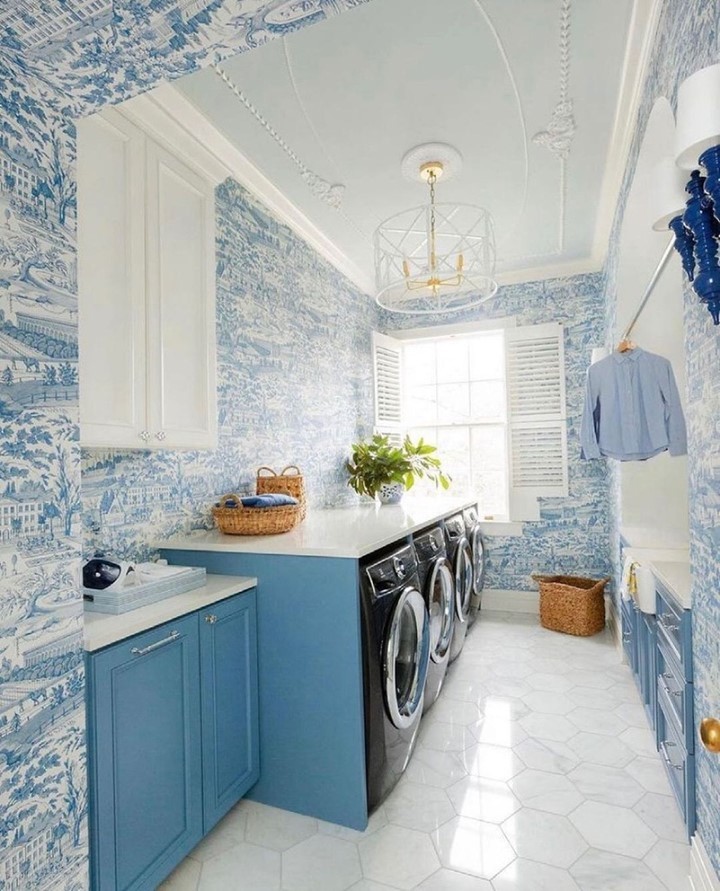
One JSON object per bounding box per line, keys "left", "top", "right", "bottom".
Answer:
{"left": 533, "top": 575, "right": 610, "bottom": 637}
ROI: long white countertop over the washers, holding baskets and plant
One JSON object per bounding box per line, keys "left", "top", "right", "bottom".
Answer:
{"left": 154, "top": 498, "right": 476, "bottom": 559}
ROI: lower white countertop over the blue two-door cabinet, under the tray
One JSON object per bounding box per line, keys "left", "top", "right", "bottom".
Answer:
{"left": 85, "top": 575, "right": 257, "bottom": 652}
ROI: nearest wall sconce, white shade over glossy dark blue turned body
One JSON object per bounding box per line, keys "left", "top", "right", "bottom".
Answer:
{"left": 668, "top": 65, "right": 720, "bottom": 325}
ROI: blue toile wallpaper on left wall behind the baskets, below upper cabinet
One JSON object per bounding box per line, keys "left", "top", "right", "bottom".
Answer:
{"left": 82, "top": 179, "right": 376, "bottom": 559}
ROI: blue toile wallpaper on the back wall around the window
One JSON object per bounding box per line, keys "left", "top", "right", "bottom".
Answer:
{"left": 380, "top": 273, "right": 611, "bottom": 591}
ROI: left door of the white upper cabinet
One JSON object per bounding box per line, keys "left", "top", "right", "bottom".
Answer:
{"left": 78, "top": 109, "right": 145, "bottom": 448}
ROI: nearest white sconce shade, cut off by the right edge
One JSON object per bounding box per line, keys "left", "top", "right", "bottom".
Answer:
{"left": 675, "top": 64, "right": 720, "bottom": 170}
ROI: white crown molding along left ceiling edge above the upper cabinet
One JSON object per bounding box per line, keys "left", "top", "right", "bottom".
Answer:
{"left": 128, "top": 84, "right": 374, "bottom": 294}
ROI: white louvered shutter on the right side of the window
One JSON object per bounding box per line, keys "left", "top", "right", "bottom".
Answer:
{"left": 505, "top": 322, "right": 568, "bottom": 520}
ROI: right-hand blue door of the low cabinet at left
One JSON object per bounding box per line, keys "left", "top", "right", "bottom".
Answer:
{"left": 199, "top": 590, "right": 259, "bottom": 832}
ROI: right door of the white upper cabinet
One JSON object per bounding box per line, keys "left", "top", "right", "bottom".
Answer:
{"left": 147, "top": 142, "right": 217, "bottom": 448}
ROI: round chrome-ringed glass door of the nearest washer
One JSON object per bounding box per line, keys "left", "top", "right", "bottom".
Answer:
{"left": 385, "top": 588, "right": 430, "bottom": 729}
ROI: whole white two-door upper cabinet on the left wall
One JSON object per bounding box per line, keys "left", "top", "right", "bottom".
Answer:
{"left": 78, "top": 109, "right": 217, "bottom": 449}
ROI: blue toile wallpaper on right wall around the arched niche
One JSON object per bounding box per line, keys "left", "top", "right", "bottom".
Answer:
{"left": 605, "top": 0, "right": 720, "bottom": 876}
